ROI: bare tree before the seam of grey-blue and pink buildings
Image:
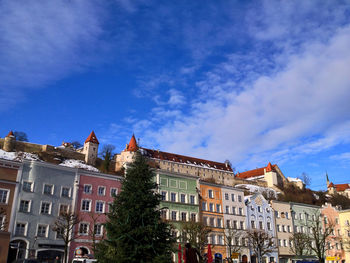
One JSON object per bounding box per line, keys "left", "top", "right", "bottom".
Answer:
{"left": 52, "top": 211, "right": 80, "bottom": 263}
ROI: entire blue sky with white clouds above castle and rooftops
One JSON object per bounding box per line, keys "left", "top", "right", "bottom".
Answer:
{"left": 0, "top": 0, "right": 350, "bottom": 189}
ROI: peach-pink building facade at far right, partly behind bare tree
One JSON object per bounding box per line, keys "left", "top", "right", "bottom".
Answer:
{"left": 321, "top": 203, "right": 345, "bottom": 263}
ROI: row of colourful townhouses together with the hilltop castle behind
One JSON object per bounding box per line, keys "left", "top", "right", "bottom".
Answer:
{"left": 0, "top": 132, "right": 350, "bottom": 263}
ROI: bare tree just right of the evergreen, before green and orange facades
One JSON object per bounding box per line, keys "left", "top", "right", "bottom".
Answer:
{"left": 181, "top": 221, "right": 211, "bottom": 256}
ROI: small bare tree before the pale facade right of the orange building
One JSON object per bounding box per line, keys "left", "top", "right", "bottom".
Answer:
{"left": 224, "top": 226, "right": 245, "bottom": 262}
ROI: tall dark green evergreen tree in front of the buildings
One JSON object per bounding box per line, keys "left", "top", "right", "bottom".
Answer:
{"left": 95, "top": 153, "right": 174, "bottom": 263}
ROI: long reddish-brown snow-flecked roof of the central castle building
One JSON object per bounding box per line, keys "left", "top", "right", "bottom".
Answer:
{"left": 141, "top": 148, "right": 232, "bottom": 172}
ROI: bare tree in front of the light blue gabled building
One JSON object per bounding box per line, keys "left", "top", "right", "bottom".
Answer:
{"left": 246, "top": 229, "right": 277, "bottom": 263}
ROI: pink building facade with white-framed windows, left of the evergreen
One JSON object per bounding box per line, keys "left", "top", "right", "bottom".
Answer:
{"left": 69, "top": 172, "right": 123, "bottom": 259}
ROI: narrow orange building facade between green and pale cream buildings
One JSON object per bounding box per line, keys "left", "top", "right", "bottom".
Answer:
{"left": 200, "top": 181, "right": 226, "bottom": 259}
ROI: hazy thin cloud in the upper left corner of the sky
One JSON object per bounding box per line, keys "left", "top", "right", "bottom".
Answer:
{"left": 0, "top": 0, "right": 103, "bottom": 110}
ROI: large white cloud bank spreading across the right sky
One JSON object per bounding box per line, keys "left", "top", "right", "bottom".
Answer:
{"left": 147, "top": 24, "right": 350, "bottom": 168}
